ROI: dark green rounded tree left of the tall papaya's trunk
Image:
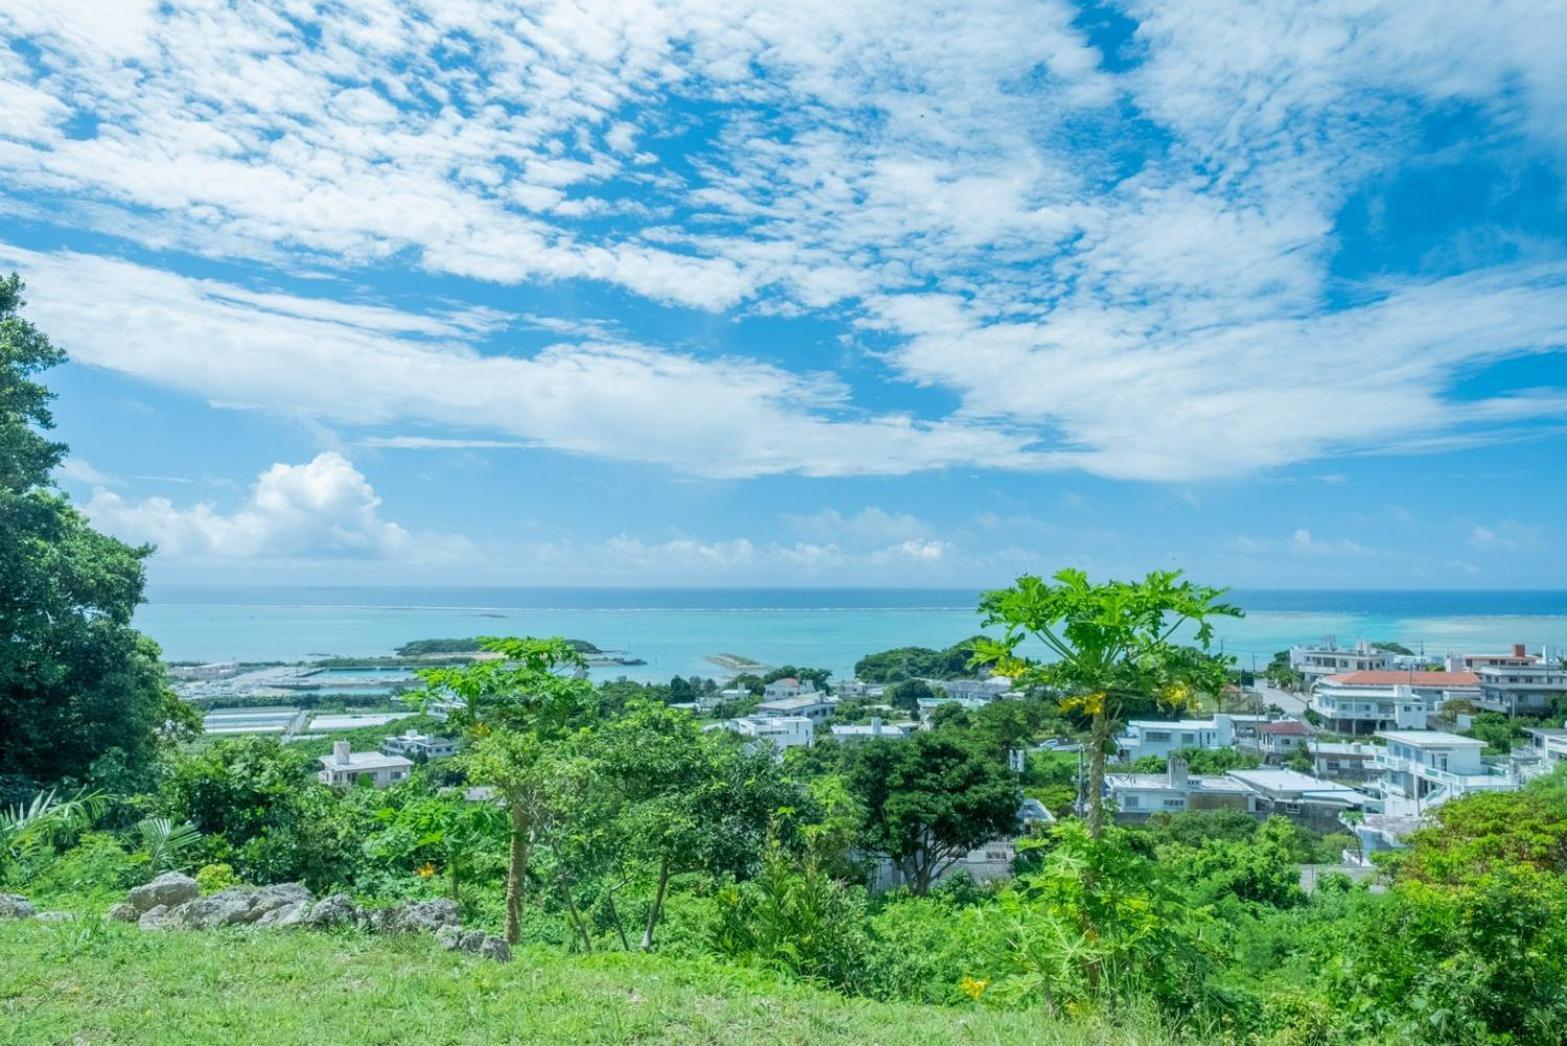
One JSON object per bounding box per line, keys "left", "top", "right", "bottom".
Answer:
{"left": 849, "top": 730, "right": 1022, "bottom": 894}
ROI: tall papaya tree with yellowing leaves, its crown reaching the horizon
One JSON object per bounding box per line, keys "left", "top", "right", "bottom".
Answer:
{"left": 975, "top": 570, "right": 1241, "bottom": 835}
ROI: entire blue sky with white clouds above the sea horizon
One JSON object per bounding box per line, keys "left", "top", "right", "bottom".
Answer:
{"left": 0, "top": 0, "right": 1567, "bottom": 587}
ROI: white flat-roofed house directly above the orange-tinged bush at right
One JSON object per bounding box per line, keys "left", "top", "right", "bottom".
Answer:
{"left": 1373, "top": 730, "right": 1520, "bottom": 816}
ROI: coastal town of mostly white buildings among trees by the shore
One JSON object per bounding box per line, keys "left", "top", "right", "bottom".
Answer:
{"left": 169, "top": 636, "right": 1567, "bottom": 888}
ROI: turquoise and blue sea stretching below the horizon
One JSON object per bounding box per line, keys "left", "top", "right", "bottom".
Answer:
{"left": 136, "top": 586, "right": 1567, "bottom": 680}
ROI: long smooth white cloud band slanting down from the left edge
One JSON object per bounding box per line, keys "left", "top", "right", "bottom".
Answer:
{"left": 0, "top": 244, "right": 1033, "bottom": 478}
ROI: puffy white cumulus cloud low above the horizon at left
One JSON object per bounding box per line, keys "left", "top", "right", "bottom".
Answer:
{"left": 85, "top": 451, "right": 472, "bottom": 562}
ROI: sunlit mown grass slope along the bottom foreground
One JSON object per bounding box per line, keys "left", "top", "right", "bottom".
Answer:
{"left": 0, "top": 922, "right": 1163, "bottom": 1046}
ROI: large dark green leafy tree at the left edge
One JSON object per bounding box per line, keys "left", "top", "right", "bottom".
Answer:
{"left": 0, "top": 274, "right": 184, "bottom": 802}
